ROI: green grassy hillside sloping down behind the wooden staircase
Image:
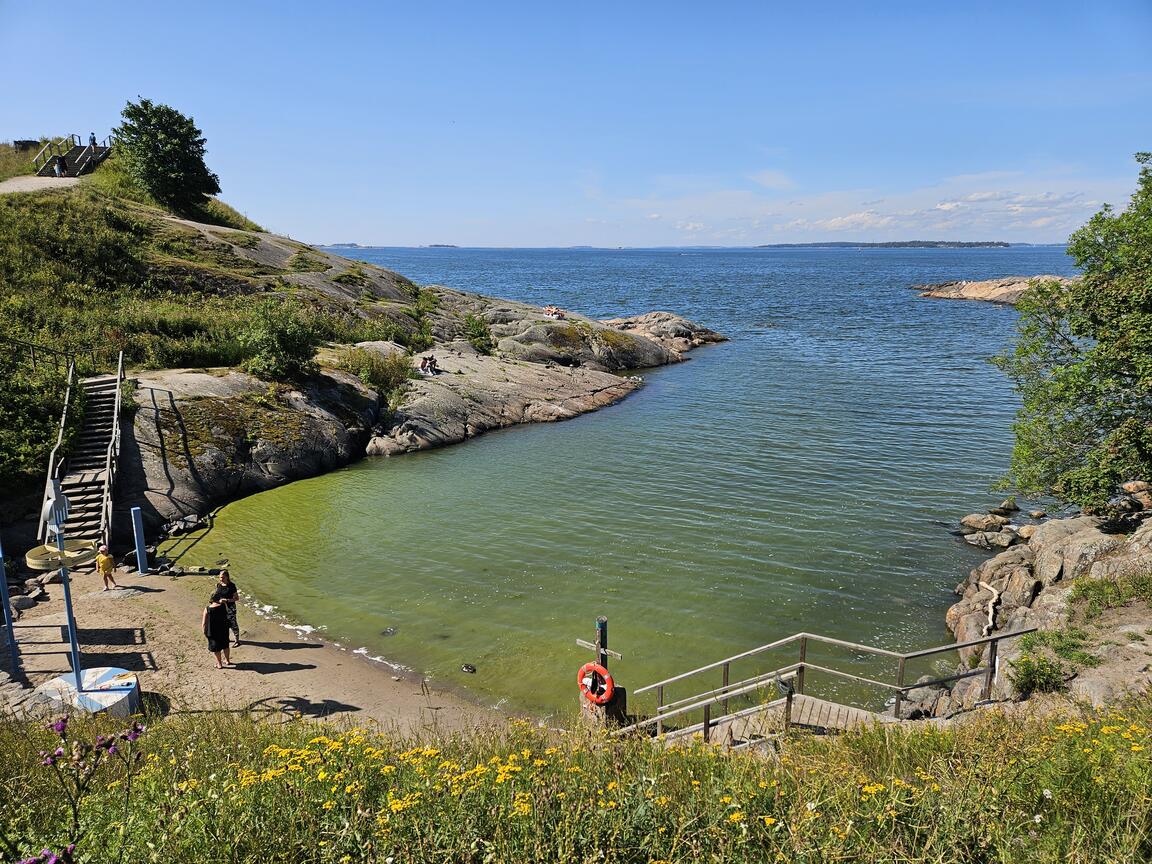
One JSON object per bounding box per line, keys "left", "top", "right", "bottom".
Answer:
{"left": 0, "top": 161, "right": 431, "bottom": 485}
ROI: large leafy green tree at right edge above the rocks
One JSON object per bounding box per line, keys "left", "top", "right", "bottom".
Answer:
{"left": 996, "top": 153, "right": 1152, "bottom": 507}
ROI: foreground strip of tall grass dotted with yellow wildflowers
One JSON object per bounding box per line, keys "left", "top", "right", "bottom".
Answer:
{"left": 0, "top": 700, "right": 1152, "bottom": 864}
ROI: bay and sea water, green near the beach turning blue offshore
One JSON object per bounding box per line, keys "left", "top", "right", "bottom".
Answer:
{"left": 185, "top": 248, "right": 1073, "bottom": 714}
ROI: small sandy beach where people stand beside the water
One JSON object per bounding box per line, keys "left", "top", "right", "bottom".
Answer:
{"left": 16, "top": 570, "right": 503, "bottom": 733}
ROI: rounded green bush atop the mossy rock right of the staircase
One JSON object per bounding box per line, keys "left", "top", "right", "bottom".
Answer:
{"left": 240, "top": 300, "right": 320, "bottom": 381}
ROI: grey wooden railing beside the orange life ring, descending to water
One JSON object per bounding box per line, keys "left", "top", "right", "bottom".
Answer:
{"left": 615, "top": 627, "right": 1037, "bottom": 741}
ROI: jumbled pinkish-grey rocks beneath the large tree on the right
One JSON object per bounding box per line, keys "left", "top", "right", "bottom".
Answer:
{"left": 902, "top": 488, "right": 1152, "bottom": 719}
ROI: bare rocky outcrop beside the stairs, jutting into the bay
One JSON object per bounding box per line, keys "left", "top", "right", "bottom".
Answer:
{"left": 114, "top": 304, "right": 726, "bottom": 537}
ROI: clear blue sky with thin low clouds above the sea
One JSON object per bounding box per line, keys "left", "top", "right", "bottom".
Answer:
{"left": 0, "top": 0, "right": 1152, "bottom": 247}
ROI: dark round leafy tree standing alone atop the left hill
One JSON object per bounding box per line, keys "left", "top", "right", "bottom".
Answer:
{"left": 115, "top": 98, "right": 220, "bottom": 212}
